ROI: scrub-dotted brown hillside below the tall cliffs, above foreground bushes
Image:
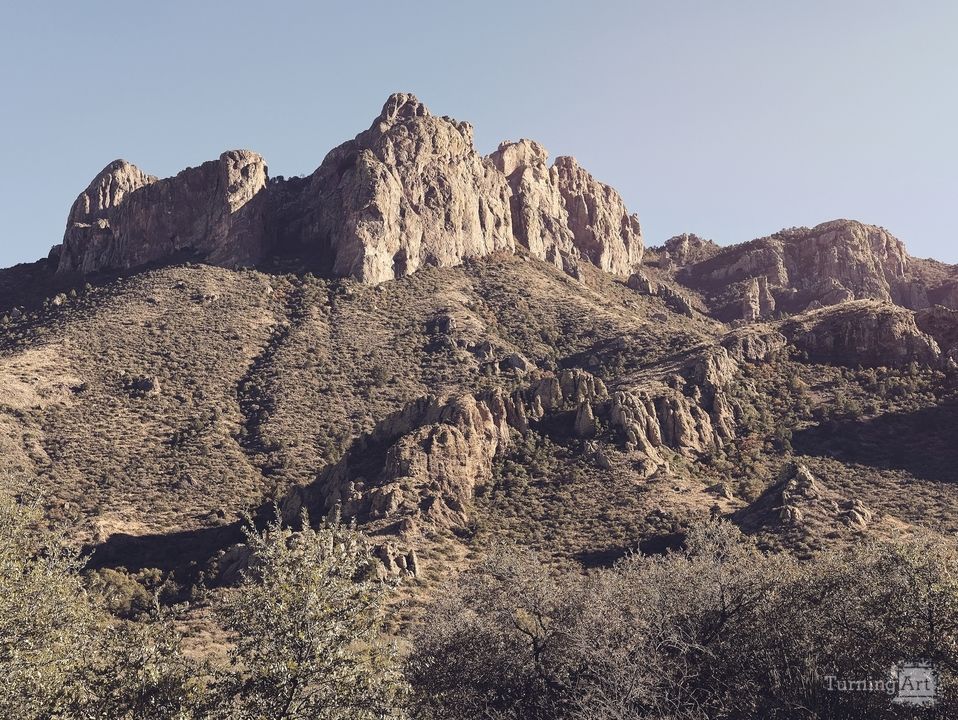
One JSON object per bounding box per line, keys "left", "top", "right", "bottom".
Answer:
{"left": 0, "top": 255, "right": 958, "bottom": 596}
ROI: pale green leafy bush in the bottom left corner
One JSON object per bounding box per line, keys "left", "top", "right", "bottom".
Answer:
{"left": 0, "top": 494, "right": 196, "bottom": 720}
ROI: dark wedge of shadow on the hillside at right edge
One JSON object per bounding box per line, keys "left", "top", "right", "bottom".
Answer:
{"left": 792, "top": 403, "right": 958, "bottom": 482}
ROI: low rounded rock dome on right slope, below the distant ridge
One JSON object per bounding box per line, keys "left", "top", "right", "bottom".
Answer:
{"left": 780, "top": 300, "right": 943, "bottom": 367}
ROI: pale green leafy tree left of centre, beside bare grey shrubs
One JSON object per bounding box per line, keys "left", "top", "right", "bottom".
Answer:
{"left": 214, "top": 519, "right": 404, "bottom": 720}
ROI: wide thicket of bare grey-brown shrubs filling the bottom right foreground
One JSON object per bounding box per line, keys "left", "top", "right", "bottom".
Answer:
{"left": 408, "top": 522, "right": 958, "bottom": 720}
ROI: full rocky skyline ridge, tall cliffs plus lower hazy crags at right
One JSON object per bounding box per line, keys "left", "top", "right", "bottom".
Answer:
{"left": 0, "top": 93, "right": 958, "bottom": 330}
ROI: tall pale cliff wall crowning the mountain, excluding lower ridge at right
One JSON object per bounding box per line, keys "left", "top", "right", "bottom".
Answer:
{"left": 57, "top": 93, "right": 642, "bottom": 284}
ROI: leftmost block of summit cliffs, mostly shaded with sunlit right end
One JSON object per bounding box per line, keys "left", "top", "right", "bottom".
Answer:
{"left": 54, "top": 150, "right": 267, "bottom": 273}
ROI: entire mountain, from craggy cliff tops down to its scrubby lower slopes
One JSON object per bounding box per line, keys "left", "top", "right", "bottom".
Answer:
{"left": 0, "top": 94, "right": 958, "bottom": 616}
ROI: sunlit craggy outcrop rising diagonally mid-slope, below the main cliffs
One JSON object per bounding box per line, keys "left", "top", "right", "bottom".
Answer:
{"left": 282, "top": 370, "right": 608, "bottom": 536}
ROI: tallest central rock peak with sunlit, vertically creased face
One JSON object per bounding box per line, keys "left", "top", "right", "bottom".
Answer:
{"left": 279, "top": 93, "right": 515, "bottom": 284}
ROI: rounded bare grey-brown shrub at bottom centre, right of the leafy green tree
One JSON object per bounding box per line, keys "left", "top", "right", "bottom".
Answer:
{"left": 407, "top": 552, "right": 581, "bottom": 720}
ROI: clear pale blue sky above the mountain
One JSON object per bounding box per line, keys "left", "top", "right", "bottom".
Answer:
{"left": 0, "top": 0, "right": 958, "bottom": 267}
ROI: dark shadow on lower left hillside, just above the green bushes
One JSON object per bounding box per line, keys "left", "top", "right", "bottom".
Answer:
{"left": 87, "top": 522, "right": 243, "bottom": 572}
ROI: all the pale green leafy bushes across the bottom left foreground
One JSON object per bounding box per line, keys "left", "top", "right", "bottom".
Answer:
{"left": 0, "top": 494, "right": 405, "bottom": 720}
